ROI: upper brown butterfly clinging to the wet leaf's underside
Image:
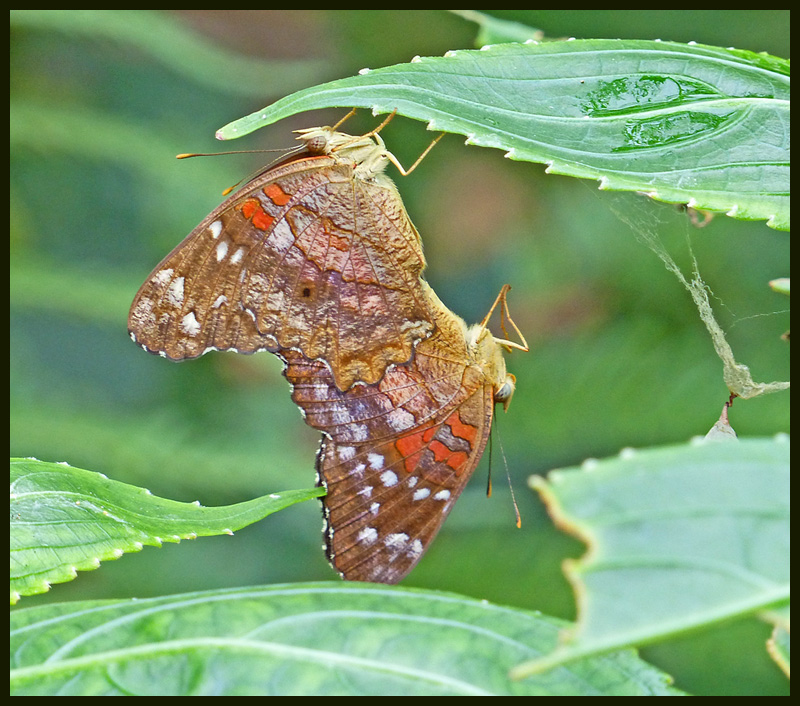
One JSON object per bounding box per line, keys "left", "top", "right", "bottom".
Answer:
{"left": 128, "top": 116, "right": 434, "bottom": 390}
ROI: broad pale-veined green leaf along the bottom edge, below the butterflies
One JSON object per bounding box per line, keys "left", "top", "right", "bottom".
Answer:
{"left": 11, "top": 583, "right": 680, "bottom": 696}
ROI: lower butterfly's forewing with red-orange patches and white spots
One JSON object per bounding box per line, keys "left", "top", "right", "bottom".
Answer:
{"left": 317, "top": 390, "right": 492, "bottom": 583}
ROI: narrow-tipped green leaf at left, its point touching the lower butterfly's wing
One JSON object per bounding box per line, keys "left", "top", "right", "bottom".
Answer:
{"left": 11, "top": 458, "right": 324, "bottom": 603}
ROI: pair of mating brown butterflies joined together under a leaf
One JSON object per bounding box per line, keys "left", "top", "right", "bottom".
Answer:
{"left": 128, "top": 116, "right": 527, "bottom": 583}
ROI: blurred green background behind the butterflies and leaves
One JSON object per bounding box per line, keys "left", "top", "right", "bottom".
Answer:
{"left": 11, "top": 10, "right": 789, "bottom": 694}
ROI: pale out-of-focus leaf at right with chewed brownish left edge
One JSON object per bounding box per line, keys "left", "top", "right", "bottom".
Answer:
{"left": 515, "top": 437, "right": 789, "bottom": 676}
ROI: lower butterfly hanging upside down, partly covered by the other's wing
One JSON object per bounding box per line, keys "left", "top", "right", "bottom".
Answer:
{"left": 279, "top": 283, "right": 528, "bottom": 583}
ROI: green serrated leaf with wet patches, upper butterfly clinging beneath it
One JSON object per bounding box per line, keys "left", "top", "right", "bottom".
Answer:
{"left": 217, "top": 39, "right": 789, "bottom": 229}
